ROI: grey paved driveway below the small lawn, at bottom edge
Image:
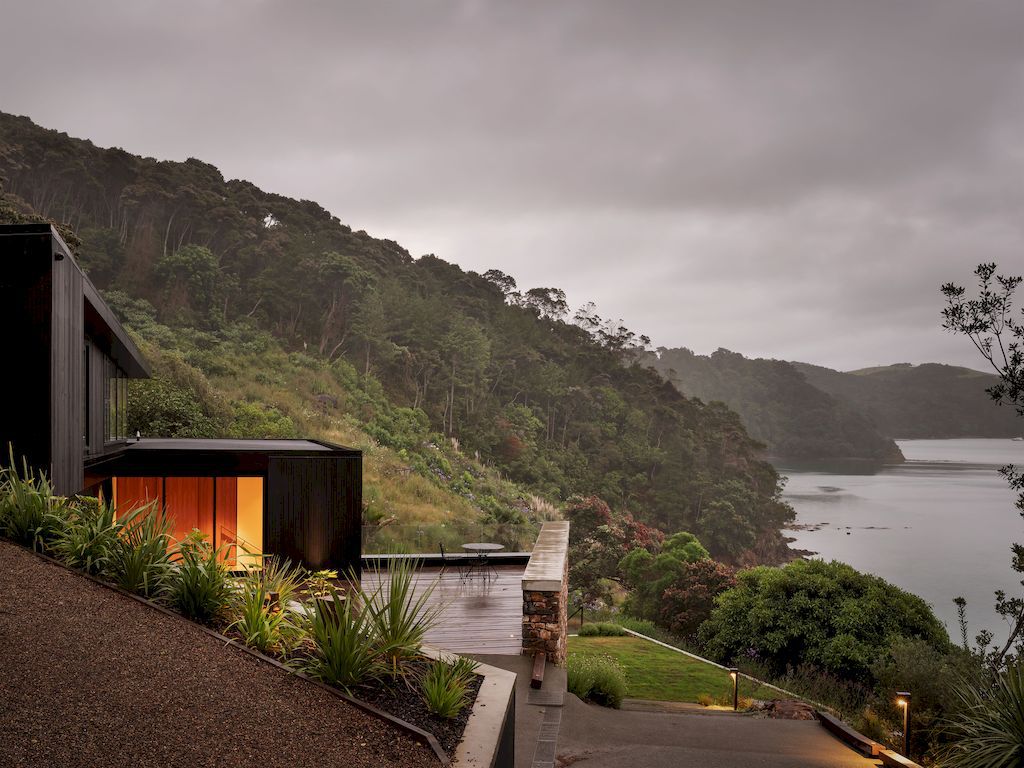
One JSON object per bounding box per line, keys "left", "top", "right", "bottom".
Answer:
{"left": 556, "top": 694, "right": 879, "bottom": 768}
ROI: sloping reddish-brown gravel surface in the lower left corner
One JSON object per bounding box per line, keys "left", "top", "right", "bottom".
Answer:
{"left": 0, "top": 541, "right": 438, "bottom": 768}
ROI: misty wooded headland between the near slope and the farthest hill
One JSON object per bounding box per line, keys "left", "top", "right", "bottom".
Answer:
{"left": 644, "top": 348, "right": 903, "bottom": 461}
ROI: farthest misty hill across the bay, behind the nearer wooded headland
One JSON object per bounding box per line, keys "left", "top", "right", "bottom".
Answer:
{"left": 793, "top": 362, "right": 1021, "bottom": 439}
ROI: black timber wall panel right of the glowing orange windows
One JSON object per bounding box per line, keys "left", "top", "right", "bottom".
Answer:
{"left": 263, "top": 456, "right": 362, "bottom": 572}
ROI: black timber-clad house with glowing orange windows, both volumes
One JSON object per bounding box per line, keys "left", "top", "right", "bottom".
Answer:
{"left": 0, "top": 224, "right": 362, "bottom": 570}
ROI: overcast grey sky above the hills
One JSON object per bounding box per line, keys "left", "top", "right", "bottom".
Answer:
{"left": 0, "top": 0, "right": 1024, "bottom": 370}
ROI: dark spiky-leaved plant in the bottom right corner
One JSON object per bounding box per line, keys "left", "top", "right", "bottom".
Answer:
{"left": 939, "top": 662, "right": 1024, "bottom": 768}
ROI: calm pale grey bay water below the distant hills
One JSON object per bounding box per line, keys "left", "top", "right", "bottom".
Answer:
{"left": 778, "top": 439, "right": 1024, "bottom": 640}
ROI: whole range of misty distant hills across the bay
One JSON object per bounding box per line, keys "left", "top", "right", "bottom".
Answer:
{"left": 644, "top": 348, "right": 1019, "bottom": 462}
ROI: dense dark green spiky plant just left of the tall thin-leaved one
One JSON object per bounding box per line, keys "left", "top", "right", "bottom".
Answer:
{"left": 300, "top": 590, "right": 380, "bottom": 692}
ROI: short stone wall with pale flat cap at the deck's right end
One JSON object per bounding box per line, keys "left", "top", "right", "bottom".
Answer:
{"left": 522, "top": 521, "right": 568, "bottom": 665}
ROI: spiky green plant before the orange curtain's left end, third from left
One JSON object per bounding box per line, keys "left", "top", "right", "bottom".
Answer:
{"left": 103, "top": 502, "right": 172, "bottom": 597}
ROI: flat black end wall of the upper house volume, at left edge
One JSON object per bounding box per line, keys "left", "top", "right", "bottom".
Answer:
{"left": 0, "top": 234, "right": 53, "bottom": 481}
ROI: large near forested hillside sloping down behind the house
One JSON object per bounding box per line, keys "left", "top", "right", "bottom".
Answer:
{"left": 0, "top": 115, "right": 792, "bottom": 559}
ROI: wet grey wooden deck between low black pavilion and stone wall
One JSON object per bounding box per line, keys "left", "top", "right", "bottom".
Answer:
{"left": 362, "top": 565, "right": 525, "bottom": 655}
